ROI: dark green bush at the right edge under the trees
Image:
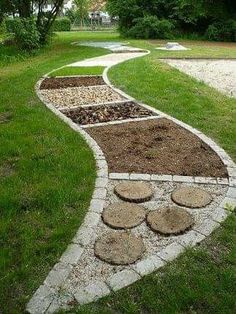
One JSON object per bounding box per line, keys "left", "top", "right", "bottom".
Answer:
{"left": 206, "top": 20, "right": 236, "bottom": 41}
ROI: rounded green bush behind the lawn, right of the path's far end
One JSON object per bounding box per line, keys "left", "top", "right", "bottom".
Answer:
{"left": 126, "top": 15, "right": 174, "bottom": 39}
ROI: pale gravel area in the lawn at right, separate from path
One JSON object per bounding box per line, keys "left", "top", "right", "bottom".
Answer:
{"left": 162, "top": 59, "right": 236, "bottom": 97}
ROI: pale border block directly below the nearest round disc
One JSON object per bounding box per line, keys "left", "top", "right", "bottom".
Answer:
{"left": 106, "top": 269, "right": 140, "bottom": 291}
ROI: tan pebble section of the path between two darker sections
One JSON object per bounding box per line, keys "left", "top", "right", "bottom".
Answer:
{"left": 40, "top": 85, "right": 124, "bottom": 108}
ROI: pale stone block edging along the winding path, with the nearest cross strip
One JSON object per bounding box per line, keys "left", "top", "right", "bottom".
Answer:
{"left": 26, "top": 50, "right": 236, "bottom": 314}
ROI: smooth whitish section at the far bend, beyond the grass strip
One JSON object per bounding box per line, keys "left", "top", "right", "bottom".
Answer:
{"left": 68, "top": 52, "right": 147, "bottom": 67}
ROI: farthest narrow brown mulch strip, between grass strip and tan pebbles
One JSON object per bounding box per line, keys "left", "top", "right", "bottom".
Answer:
{"left": 40, "top": 76, "right": 105, "bottom": 89}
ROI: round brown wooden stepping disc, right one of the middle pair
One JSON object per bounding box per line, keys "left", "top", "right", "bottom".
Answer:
{"left": 147, "top": 207, "right": 194, "bottom": 235}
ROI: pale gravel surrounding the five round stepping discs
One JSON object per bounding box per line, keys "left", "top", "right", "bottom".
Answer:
{"left": 60, "top": 180, "right": 228, "bottom": 294}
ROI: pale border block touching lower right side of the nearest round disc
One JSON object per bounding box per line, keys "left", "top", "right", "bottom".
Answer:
{"left": 132, "top": 256, "right": 164, "bottom": 276}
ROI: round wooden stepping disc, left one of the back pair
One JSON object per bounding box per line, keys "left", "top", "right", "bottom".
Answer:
{"left": 115, "top": 182, "right": 153, "bottom": 203}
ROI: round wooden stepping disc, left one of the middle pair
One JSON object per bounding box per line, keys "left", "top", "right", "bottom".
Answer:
{"left": 102, "top": 203, "right": 146, "bottom": 229}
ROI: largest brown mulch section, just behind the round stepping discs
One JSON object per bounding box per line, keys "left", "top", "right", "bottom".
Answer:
{"left": 87, "top": 119, "right": 227, "bottom": 177}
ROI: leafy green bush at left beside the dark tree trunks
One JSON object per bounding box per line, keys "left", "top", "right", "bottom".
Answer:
{"left": 13, "top": 18, "right": 40, "bottom": 51}
